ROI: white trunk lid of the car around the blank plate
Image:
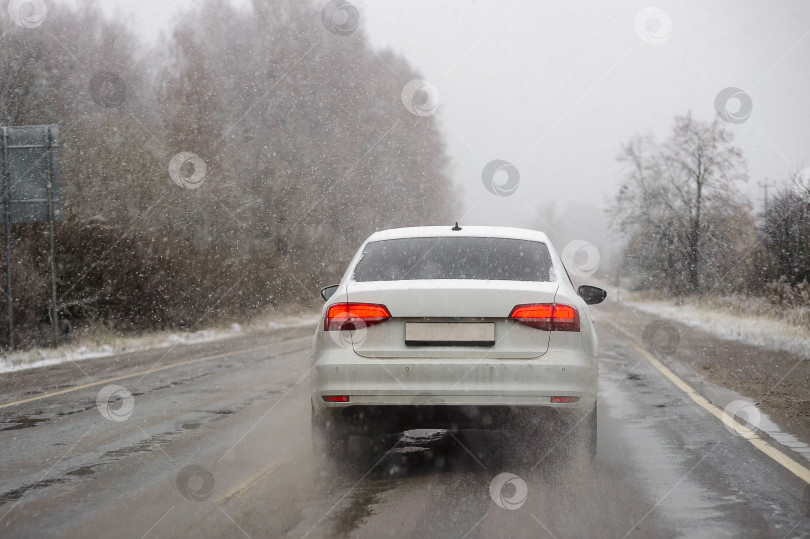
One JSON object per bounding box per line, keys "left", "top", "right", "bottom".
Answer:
{"left": 347, "top": 279, "right": 559, "bottom": 359}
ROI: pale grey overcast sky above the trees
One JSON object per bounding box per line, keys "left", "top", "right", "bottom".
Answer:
{"left": 96, "top": 0, "right": 810, "bottom": 236}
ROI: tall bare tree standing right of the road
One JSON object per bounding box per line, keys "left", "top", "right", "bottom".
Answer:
{"left": 610, "top": 114, "right": 753, "bottom": 294}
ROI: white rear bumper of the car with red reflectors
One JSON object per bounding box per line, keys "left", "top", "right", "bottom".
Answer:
{"left": 311, "top": 349, "right": 597, "bottom": 411}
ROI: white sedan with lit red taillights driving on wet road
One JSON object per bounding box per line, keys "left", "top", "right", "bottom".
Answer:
{"left": 311, "top": 224, "right": 606, "bottom": 458}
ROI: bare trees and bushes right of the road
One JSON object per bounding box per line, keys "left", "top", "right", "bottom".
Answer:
{"left": 609, "top": 115, "right": 810, "bottom": 306}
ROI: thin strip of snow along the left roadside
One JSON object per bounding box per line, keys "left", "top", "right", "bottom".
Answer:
{"left": 0, "top": 314, "right": 319, "bottom": 374}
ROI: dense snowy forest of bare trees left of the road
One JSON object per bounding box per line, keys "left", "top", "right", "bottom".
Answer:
{"left": 0, "top": 0, "right": 456, "bottom": 345}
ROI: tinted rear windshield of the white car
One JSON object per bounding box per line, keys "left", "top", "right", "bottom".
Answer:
{"left": 354, "top": 237, "right": 553, "bottom": 282}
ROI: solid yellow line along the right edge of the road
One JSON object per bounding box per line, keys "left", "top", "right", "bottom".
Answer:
{"left": 605, "top": 321, "right": 810, "bottom": 484}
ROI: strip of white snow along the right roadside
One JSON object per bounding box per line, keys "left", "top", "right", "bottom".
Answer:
{"left": 626, "top": 301, "right": 810, "bottom": 359}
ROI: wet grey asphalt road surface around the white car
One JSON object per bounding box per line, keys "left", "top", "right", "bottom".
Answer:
{"left": 0, "top": 310, "right": 810, "bottom": 538}
